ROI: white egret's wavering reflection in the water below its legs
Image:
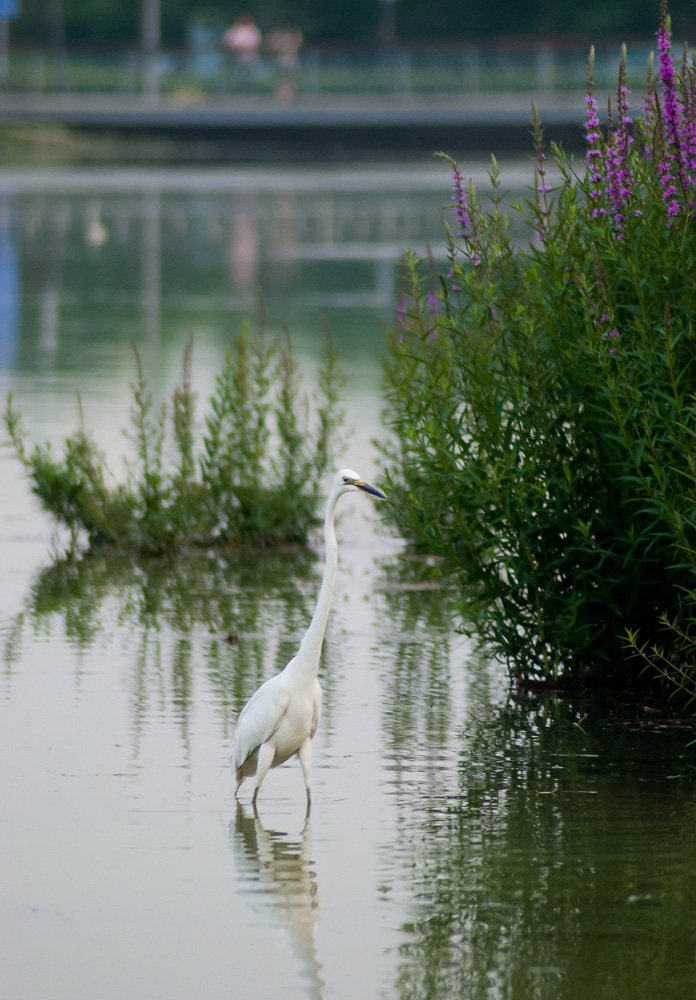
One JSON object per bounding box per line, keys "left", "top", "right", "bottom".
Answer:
{"left": 230, "top": 802, "right": 324, "bottom": 1000}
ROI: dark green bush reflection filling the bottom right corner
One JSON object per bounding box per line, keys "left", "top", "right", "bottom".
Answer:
{"left": 388, "top": 701, "right": 696, "bottom": 1000}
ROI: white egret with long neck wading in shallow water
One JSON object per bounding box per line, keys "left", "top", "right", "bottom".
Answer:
{"left": 230, "top": 469, "right": 385, "bottom": 815}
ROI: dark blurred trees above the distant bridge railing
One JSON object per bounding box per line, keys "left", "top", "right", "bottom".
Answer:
{"left": 11, "top": 0, "right": 696, "bottom": 48}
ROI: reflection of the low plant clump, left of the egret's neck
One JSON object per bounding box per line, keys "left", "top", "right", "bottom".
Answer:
{"left": 5, "top": 548, "right": 340, "bottom": 744}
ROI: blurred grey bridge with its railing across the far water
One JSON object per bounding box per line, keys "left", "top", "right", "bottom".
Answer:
{"left": 0, "top": 38, "right": 664, "bottom": 159}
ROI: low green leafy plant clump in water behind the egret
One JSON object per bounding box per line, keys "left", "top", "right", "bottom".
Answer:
{"left": 5, "top": 327, "right": 342, "bottom": 552}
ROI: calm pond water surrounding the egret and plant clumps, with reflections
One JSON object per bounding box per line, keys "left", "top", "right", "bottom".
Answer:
{"left": 0, "top": 168, "right": 696, "bottom": 1000}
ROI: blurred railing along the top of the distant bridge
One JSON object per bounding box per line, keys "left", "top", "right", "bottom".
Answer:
{"left": 0, "top": 42, "right": 668, "bottom": 102}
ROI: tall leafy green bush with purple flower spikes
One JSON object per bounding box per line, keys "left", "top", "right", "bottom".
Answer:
{"left": 382, "top": 9, "right": 696, "bottom": 684}
